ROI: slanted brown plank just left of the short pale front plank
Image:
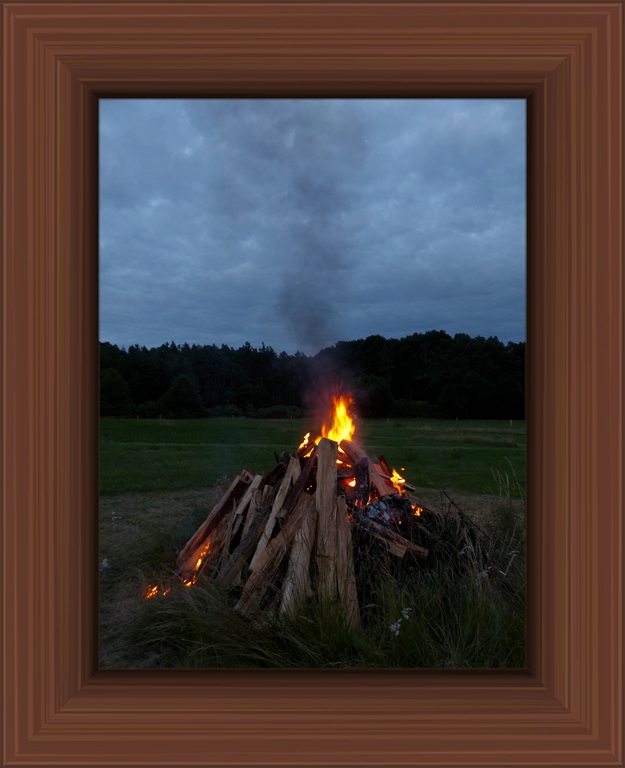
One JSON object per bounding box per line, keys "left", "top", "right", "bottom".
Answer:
{"left": 234, "top": 494, "right": 315, "bottom": 616}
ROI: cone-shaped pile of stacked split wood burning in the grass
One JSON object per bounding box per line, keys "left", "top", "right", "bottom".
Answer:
{"left": 167, "top": 438, "right": 448, "bottom": 624}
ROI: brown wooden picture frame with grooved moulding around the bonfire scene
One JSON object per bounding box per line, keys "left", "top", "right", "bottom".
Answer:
{"left": 2, "top": 0, "right": 623, "bottom": 766}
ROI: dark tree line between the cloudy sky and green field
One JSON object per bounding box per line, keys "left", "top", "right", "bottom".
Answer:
{"left": 100, "top": 331, "right": 525, "bottom": 419}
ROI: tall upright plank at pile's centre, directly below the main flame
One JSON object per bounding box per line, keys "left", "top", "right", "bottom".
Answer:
{"left": 315, "top": 437, "right": 338, "bottom": 600}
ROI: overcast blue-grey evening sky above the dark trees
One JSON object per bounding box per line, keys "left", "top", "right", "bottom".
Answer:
{"left": 100, "top": 99, "right": 526, "bottom": 354}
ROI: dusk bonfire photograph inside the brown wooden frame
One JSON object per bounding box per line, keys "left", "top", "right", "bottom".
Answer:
{"left": 98, "top": 98, "right": 527, "bottom": 670}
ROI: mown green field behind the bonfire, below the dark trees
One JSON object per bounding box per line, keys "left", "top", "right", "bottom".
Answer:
{"left": 100, "top": 418, "right": 525, "bottom": 494}
